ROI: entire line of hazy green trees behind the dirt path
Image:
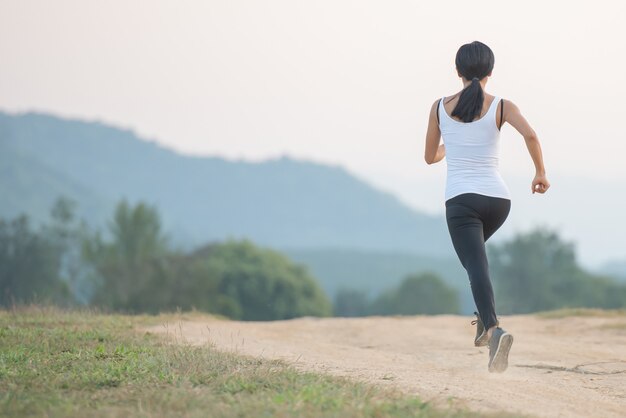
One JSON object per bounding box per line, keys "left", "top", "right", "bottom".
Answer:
{"left": 0, "top": 198, "right": 626, "bottom": 321}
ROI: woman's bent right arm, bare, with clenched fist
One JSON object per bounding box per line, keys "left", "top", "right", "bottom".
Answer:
{"left": 504, "top": 100, "right": 550, "bottom": 193}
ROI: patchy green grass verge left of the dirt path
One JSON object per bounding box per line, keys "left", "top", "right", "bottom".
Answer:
{"left": 0, "top": 307, "right": 514, "bottom": 418}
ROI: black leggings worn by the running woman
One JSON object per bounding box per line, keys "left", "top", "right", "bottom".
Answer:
{"left": 446, "top": 193, "right": 511, "bottom": 329}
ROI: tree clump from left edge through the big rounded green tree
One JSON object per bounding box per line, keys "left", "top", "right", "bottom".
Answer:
{"left": 0, "top": 199, "right": 332, "bottom": 320}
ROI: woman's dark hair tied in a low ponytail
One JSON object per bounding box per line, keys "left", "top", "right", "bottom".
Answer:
{"left": 452, "top": 41, "right": 495, "bottom": 122}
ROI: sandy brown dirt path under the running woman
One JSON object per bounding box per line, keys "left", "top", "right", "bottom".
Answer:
{"left": 150, "top": 316, "right": 626, "bottom": 418}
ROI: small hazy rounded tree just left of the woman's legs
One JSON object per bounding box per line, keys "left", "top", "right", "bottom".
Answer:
{"left": 372, "top": 273, "right": 460, "bottom": 315}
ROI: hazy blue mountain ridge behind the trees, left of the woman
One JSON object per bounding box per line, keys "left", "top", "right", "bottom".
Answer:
{"left": 0, "top": 112, "right": 451, "bottom": 255}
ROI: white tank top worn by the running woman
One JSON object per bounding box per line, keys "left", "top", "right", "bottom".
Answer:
{"left": 439, "top": 97, "right": 511, "bottom": 200}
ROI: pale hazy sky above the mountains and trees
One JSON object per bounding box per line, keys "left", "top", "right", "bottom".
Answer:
{"left": 0, "top": 0, "right": 626, "bottom": 265}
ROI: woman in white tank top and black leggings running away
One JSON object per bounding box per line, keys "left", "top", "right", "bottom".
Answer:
{"left": 424, "top": 41, "right": 550, "bottom": 372}
